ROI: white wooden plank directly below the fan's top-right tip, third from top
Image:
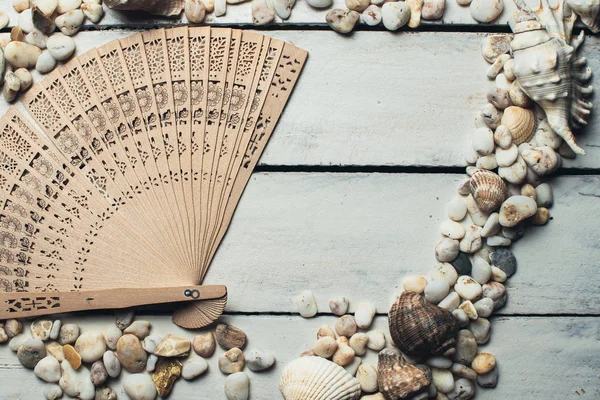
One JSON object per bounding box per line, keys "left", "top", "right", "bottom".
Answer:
{"left": 200, "top": 173, "right": 600, "bottom": 314}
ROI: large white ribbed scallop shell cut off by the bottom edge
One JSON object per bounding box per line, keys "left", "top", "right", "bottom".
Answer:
{"left": 279, "top": 356, "right": 360, "bottom": 400}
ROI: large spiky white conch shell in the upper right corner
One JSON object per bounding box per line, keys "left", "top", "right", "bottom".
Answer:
{"left": 511, "top": 0, "right": 593, "bottom": 154}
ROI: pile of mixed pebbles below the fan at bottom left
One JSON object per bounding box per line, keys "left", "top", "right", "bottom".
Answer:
{"left": 0, "top": 312, "right": 275, "bottom": 400}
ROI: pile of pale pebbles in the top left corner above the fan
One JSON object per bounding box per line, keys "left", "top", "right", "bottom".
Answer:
{"left": 0, "top": 0, "right": 104, "bottom": 102}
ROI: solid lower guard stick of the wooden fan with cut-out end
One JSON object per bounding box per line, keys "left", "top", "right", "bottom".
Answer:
{"left": 0, "top": 285, "right": 227, "bottom": 320}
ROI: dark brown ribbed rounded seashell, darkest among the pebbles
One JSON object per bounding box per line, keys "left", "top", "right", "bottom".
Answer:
{"left": 388, "top": 292, "right": 458, "bottom": 356}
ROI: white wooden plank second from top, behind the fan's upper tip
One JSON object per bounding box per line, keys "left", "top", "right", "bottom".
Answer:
{"left": 0, "top": 31, "right": 600, "bottom": 168}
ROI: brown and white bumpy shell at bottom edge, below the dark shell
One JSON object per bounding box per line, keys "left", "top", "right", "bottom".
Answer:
{"left": 377, "top": 349, "right": 431, "bottom": 400}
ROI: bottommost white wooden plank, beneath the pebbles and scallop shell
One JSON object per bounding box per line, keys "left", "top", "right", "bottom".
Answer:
{"left": 0, "top": 316, "right": 600, "bottom": 400}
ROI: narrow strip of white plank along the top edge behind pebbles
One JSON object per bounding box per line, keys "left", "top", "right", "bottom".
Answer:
{"left": 0, "top": 0, "right": 588, "bottom": 29}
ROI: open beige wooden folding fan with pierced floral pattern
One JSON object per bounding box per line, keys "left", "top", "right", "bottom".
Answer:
{"left": 0, "top": 27, "right": 307, "bottom": 328}
